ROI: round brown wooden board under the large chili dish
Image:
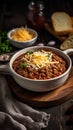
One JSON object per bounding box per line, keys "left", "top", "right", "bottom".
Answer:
{"left": 7, "top": 67, "right": 73, "bottom": 107}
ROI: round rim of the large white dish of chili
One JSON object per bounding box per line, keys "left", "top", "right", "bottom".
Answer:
{"left": 9, "top": 46, "right": 72, "bottom": 82}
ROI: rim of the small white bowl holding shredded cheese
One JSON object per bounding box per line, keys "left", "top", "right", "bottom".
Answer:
{"left": 7, "top": 27, "right": 38, "bottom": 43}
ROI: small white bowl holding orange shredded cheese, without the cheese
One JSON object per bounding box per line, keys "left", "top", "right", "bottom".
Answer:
{"left": 7, "top": 28, "right": 38, "bottom": 48}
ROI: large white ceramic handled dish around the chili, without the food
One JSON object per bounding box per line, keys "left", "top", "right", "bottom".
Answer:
{"left": 2, "top": 46, "right": 73, "bottom": 92}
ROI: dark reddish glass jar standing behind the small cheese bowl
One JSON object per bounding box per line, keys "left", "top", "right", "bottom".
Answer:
{"left": 26, "top": 1, "right": 45, "bottom": 31}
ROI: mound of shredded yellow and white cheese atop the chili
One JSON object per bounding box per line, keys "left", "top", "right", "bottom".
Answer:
{"left": 22, "top": 50, "right": 59, "bottom": 69}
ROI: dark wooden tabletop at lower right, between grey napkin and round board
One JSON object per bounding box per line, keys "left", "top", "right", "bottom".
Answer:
{"left": 41, "top": 100, "right": 73, "bottom": 130}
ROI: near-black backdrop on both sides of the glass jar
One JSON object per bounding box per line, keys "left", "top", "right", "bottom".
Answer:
{"left": 0, "top": 0, "right": 73, "bottom": 29}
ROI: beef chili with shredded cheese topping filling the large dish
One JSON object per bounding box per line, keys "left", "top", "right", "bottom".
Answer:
{"left": 12, "top": 49, "right": 67, "bottom": 80}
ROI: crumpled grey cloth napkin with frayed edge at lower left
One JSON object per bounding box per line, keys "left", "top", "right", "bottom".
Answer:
{"left": 0, "top": 75, "right": 50, "bottom": 130}
